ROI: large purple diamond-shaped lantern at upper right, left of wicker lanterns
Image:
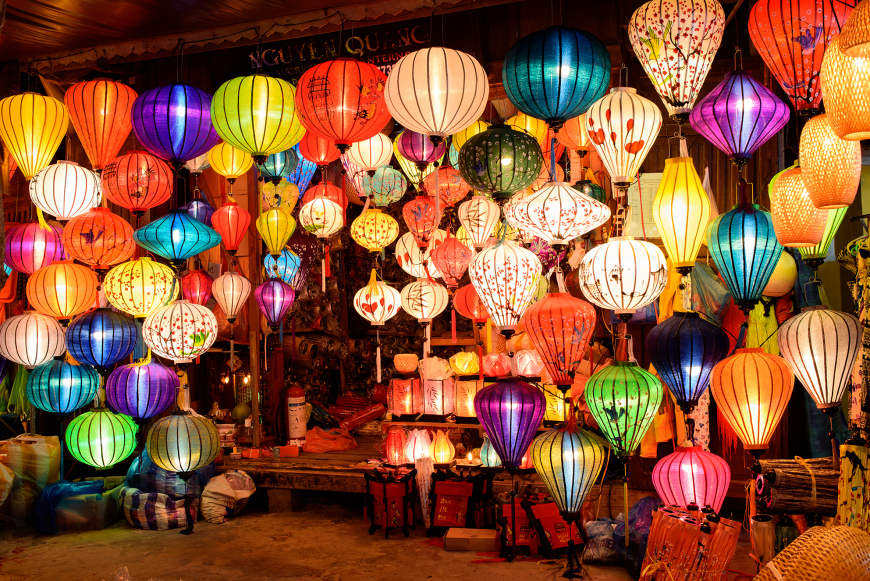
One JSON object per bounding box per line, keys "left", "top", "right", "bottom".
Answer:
{"left": 689, "top": 70, "right": 789, "bottom": 169}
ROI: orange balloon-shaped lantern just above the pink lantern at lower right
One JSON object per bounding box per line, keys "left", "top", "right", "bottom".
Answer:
{"left": 710, "top": 349, "right": 794, "bottom": 454}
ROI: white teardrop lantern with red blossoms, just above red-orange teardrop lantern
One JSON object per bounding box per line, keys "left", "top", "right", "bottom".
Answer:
{"left": 468, "top": 240, "right": 541, "bottom": 331}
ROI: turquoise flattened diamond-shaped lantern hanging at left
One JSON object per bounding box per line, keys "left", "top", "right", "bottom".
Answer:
{"left": 133, "top": 210, "right": 221, "bottom": 266}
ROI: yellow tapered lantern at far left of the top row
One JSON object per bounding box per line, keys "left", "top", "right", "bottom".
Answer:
{"left": 0, "top": 93, "right": 69, "bottom": 179}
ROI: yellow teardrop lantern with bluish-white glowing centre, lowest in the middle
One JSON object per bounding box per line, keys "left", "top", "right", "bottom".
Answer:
{"left": 530, "top": 430, "right": 605, "bottom": 525}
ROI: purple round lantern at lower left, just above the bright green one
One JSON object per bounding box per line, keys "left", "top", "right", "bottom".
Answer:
{"left": 106, "top": 359, "right": 180, "bottom": 419}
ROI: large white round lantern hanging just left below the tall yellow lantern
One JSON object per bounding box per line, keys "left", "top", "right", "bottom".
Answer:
{"left": 579, "top": 236, "right": 668, "bottom": 314}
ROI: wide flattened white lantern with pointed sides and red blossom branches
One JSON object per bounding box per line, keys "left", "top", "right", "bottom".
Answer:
{"left": 508, "top": 182, "right": 610, "bottom": 245}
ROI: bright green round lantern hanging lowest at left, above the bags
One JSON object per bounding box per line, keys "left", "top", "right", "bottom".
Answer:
{"left": 65, "top": 408, "right": 139, "bottom": 470}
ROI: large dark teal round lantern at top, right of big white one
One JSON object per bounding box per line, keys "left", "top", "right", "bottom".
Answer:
{"left": 501, "top": 26, "right": 610, "bottom": 131}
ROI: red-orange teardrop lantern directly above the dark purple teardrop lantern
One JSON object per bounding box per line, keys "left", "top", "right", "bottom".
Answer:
{"left": 523, "top": 292, "right": 595, "bottom": 391}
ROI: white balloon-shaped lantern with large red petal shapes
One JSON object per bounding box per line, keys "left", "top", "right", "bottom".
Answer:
{"left": 586, "top": 87, "right": 662, "bottom": 188}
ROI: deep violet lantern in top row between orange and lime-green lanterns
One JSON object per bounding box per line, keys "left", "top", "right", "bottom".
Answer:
{"left": 131, "top": 84, "right": 220, "bottom": 169}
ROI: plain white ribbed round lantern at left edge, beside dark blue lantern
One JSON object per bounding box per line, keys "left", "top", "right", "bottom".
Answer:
{"left": 0, "top": 311, "right": 66, "bottom": 369}
